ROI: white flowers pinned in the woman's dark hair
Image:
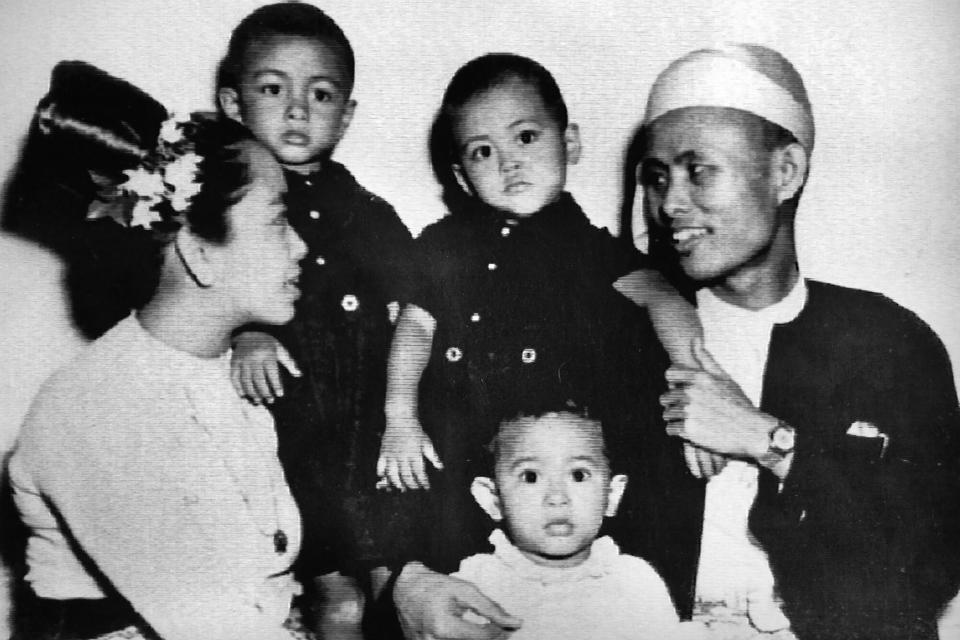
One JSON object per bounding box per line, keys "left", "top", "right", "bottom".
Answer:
{"left": 87, "top": 116, "right": 202, "bottom": 230}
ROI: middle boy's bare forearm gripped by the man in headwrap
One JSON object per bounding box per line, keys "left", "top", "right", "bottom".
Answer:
{"left": 613, "top": 269, "right": 703, "bottom": 367}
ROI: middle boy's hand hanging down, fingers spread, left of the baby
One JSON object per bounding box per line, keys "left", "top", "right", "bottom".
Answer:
{"left": 377, "top": 413, "right": 443, "bottom": 491}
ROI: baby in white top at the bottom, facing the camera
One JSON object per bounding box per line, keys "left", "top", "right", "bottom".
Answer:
{"left": 454, "top": 407, "right": 702, "bottom": 640}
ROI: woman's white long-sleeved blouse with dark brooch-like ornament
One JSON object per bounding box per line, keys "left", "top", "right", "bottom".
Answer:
{"left": 10, "top": 316, "right": 300, "bottom": 640}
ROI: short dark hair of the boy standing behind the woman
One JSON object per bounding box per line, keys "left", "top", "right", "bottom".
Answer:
{"left": 217, "top": 0, "right": 355, "bottom": 94}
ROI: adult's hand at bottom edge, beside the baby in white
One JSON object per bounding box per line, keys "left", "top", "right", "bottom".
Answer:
{"left": 393, "top": 562, "right": 521, "bottom": 640}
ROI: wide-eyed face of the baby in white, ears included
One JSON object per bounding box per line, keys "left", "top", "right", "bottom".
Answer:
{"left": 474, "top": 413, "right": 626, "bottom": 567}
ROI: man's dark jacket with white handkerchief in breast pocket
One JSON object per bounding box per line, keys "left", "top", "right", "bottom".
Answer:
{"left": 751, "top": 299, "right": 960, "bottom": 637}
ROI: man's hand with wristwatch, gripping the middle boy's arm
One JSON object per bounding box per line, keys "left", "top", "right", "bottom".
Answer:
{"left": 660, "top": 338, "right": 777, "bottom": 465}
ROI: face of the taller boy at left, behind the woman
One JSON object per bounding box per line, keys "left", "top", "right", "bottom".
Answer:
{"left": 219, "top": 35, "right": 356, "bottom": 173}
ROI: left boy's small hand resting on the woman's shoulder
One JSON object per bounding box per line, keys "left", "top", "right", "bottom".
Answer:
{"left": 230, "top": 331, "right": 301, "bottom": 404}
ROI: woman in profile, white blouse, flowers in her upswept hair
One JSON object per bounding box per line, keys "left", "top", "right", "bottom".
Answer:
{"left": 9, "top": 63, "right": 314, "bottom": 640}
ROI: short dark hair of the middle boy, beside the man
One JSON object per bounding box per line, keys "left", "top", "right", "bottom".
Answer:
{"left": 440, "top": 53, "right": 568, "bottom": 162}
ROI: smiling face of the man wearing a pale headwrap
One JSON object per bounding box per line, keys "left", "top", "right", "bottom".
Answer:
{"left": 637, "top": 107, "right": 792, "bottom": 281}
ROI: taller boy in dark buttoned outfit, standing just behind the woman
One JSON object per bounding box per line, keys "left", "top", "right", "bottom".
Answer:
{"left": 217, "top": 2, "right": 412, "bottom": 637}
